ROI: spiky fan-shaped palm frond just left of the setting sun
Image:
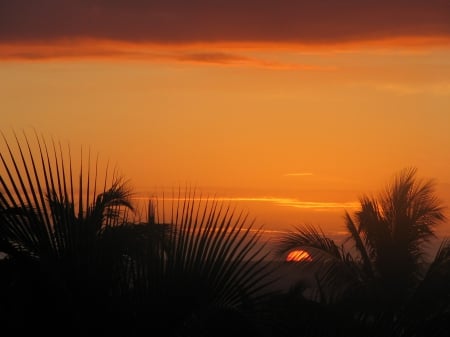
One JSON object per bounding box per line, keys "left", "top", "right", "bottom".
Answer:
{"left": 128, "top": 191, "right": 273, "bottom": 329}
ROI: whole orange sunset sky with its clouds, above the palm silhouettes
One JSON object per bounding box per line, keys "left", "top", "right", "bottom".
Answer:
{"left": 0, "top": 0, "right": 450, "bottom": 239}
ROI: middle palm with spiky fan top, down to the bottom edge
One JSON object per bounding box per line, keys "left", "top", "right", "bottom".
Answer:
{"left": 124, "top": 190, "right": 274, "bottom": 336}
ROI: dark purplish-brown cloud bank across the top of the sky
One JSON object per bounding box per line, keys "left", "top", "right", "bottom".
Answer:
{"left": 0, "top": 0, "right": 450, "bottom": 43}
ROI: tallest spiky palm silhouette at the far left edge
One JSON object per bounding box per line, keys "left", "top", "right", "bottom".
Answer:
{"left": 0, "top": 129, "right": 142, "bottom": 334}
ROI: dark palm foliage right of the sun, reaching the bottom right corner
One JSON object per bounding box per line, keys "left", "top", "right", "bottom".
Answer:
{"left": 278, "top": 168, "right": 450, "bottom": 336}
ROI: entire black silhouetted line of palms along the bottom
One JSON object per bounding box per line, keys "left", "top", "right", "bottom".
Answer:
{"left": 0, "top": 134, "right": 450, "bottom": 337}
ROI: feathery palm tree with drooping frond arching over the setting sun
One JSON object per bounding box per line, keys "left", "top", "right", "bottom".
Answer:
{"left": 278, "top": 168, "right": 447, "bottom": 334}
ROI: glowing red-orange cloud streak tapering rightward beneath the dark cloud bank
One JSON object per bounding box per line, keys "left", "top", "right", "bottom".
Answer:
{"left": 0, "top": 40, "right": 337, "bottom": 71}
